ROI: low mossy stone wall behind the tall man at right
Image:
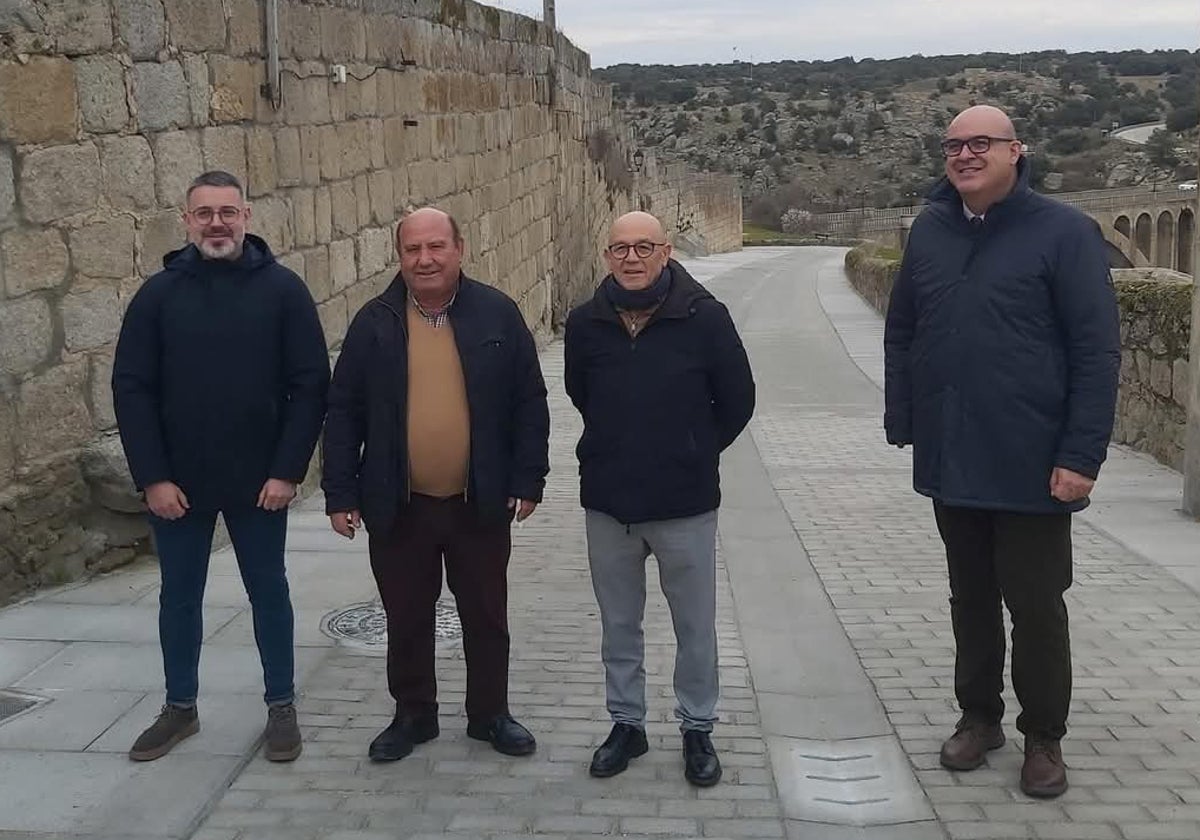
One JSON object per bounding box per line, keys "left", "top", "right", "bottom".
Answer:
{"left": 846, "top": 244, "right": 1193, "bottom": 469}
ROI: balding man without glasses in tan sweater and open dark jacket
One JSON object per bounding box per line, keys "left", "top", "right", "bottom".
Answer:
{"left": 322, "top": 208, "right": 550, "bottom": 761}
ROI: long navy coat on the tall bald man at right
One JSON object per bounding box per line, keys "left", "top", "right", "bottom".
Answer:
{"left": 884, "top": 160, "right": 1121, "bottom": 512}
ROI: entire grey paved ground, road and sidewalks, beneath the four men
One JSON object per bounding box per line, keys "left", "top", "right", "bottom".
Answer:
{"left": 0, "top": 248, "right": 1200, "bottom": 840}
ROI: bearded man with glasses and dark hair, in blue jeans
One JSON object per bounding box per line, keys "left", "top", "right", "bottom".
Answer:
{"left": 113, "top": 172, "right": 329, "bottom": 761}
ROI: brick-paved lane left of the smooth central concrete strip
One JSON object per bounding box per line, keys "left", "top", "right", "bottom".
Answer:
{"left": 194, "top": 344, "right": 784, "bottom": 840}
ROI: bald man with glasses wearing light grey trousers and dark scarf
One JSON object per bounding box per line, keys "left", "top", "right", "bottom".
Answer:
{"left": 565, "top": 212, "right": 755, "bottom": 787}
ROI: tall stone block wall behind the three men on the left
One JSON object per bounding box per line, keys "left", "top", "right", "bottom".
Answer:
{"left": 0, "top": 0, "right": 740, "bottom": 600}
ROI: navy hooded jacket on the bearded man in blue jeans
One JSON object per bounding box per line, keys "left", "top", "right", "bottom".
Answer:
{"left": 113, "top": 234, "right": 329, "bottom": 510}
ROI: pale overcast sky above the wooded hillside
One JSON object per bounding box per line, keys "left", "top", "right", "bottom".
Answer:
{"left": 484, "top": 0, "right": 1200, "bottom": 67}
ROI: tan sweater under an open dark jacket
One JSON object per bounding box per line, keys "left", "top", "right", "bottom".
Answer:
{"left": 408, "top": 305, "right": 470, "bottom": 498}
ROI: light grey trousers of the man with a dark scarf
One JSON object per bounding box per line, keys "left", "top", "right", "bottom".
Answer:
{"left": 587, "top": 510, "right": 720, "bottom": 732}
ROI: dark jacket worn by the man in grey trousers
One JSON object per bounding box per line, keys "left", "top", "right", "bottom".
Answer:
{"left": 564, "top": 260, "right": 755, "bottom": 524}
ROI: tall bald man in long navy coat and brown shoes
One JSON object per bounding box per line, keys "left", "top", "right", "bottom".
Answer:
{"left": 884, "top": 106, "right": 1121, "bottom": 797}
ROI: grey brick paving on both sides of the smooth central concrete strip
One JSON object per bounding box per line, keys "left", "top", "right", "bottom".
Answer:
{"left": 194, "top": 248, "right": 1200, "bottom": 840}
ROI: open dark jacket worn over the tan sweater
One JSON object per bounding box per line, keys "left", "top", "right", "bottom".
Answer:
{"left": 320, "top": 275, "right": 550, "bottom": 534}
